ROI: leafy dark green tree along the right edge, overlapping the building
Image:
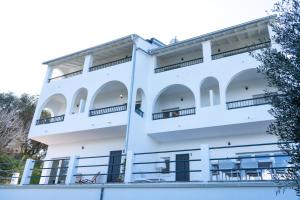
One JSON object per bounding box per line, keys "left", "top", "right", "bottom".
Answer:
{"left": 254, "top": 0, "right": 300, "bottom": 195}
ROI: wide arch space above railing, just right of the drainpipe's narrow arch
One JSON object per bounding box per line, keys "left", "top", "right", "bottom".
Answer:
{"left": 153, "top": 84, "right": 195, "bottom": 113}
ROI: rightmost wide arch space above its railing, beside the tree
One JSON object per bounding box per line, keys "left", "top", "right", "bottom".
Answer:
{"left": 225, "top": 68, "right": 276, "bottom": 102}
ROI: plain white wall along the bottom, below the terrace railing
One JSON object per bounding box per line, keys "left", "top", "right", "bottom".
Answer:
{"left": 0, "top": 183, "right": 298, "bottom": 200}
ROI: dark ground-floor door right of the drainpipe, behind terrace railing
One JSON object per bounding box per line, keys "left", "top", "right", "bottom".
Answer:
{"left": 176, "top": 154, "right": 190, "bottom": 181}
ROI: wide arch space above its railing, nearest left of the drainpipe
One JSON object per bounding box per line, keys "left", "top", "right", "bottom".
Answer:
{"left": 90, "top": 81, "right": 128, "bottom": 110}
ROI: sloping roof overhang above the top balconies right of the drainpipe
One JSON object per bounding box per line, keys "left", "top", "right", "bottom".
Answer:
{"left": 149, "top": 15, "right": 276, "bottom": 55}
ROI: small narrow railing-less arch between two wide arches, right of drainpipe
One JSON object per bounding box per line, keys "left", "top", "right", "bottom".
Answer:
{"left": 200, "top": 77, "right": 220, "bottom": 107}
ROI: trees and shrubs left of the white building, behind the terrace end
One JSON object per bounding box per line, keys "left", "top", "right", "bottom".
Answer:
{"left": 0, "top": 93, "right": 47, "bottom": 159}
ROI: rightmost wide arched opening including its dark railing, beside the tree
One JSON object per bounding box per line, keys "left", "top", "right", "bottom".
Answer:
{"left": 226, "top": 68, "right": 276, "bottom": 109}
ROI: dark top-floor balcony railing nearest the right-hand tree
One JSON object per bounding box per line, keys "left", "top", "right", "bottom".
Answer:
{"left": 211, "top": 41, "right": 271, "bottom": 60}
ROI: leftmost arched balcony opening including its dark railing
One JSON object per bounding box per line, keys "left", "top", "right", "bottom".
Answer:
{"left": 36, "top": 94, "right": 67, "bottom": 125}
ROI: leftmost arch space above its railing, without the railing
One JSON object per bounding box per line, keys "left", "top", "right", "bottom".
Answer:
{"left": 38, "top": 94, "right": 67, "bottom": 118}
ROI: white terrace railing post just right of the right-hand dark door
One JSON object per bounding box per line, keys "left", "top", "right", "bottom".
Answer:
{"left": 200, "top": 144, "right": 211, "bottom": 182}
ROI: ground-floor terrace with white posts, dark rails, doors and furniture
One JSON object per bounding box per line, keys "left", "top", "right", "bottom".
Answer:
{"left": 0, "top": 143, "right": 295, "bottom": 185}
